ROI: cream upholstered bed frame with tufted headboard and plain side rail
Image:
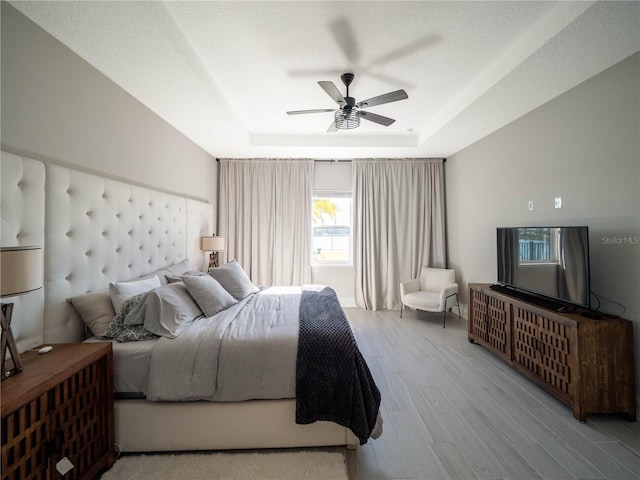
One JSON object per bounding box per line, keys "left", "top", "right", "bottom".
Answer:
{"left": 2, "top": 152, "right": 378, "bottom": 452}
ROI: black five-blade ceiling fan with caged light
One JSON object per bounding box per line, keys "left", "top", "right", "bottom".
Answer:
{"left": 287, "top": 73, "right": 409, "bottom": 132}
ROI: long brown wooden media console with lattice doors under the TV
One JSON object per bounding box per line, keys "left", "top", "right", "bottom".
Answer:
{"left": 469, "top": 284, "right": 636, "bottom": 422}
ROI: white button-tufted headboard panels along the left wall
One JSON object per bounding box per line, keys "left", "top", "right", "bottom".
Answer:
{"left": 1, "top": 152, "right": 213, "bottom": 351}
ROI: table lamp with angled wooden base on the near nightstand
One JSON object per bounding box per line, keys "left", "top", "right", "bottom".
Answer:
{"left": 0, "top": 247, "right": 42, "bottom": 380}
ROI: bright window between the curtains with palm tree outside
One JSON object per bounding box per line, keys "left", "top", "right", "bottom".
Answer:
{"left": 311, "top": 191, "right": 352, "bottom": 265}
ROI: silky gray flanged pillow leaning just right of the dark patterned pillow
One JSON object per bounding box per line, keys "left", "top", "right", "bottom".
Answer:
{"left": 124, "top": 277, "right": 202, "bottom": 338}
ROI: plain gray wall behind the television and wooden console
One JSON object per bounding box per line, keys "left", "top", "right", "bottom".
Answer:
{"left": 446, "top": 54, "right": 640, "bottom": 398}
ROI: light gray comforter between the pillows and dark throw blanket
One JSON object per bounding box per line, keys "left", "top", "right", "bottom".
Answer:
{"left": 146, "top": 286, "right": 304, "bottom": 401}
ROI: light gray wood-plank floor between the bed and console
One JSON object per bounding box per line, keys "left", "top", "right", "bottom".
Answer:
{"left": 345, "top": 308, "right": 640, "bottom": 480}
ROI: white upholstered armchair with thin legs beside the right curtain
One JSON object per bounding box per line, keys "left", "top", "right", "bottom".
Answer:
{"left": 400, "top": 267, "right": 460, "bottom": 328}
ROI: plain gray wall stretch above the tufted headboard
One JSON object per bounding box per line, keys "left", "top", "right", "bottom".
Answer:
{"left": 0, "top": 2, "right": 217, "bottom": 208}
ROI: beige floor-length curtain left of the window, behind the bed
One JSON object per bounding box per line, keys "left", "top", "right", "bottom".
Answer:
{"left": 217, "top": 159, "right": 313, "bottom": 286}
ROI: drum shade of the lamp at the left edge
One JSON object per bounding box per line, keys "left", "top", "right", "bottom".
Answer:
{"left": 0, "top": 247, "right": 42, "bottom": 297}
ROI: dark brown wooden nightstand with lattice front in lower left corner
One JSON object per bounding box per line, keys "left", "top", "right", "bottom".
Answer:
{"left": 1, "top": 343, "right": 115, "bottom": 480}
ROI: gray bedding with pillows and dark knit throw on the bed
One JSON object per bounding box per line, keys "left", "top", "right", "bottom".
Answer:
{"left": 77, "top": 261, "right": 381, "bottom": 450}
